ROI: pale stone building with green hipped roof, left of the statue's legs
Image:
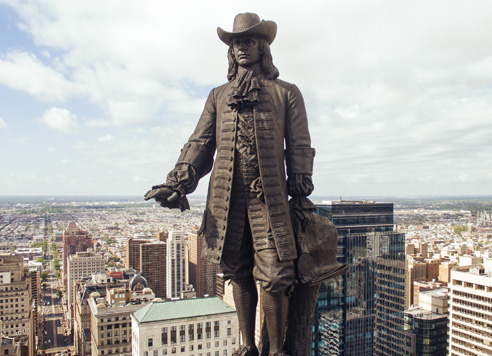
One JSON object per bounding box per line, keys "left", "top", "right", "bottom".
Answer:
{"left": 131, "top": 297, "right": 239, "bottom": 356}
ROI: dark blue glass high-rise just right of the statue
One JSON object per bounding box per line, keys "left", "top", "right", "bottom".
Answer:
{"left": 312, "top": 201, "right": 405, "bottom": 356}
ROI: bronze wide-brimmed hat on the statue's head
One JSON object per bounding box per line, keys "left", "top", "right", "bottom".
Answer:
{"left": 217, "top": 12, "right": 277, "bottom": 46}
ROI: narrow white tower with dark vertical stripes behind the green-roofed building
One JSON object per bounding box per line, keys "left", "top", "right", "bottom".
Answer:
{"left": 167, "top": 231, "right": 188, "bottom": 299}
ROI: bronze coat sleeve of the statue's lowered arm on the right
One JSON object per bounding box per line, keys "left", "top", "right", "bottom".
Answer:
{"left": 285, "top": 84, "right": 315, "bottom": 177}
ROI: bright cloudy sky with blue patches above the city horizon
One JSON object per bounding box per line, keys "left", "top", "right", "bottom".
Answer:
{"left": 0, "top": 0, "right": 492, "bottom": 196}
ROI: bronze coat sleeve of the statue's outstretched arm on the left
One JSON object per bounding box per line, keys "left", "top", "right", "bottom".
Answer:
{"left": 167, "top": 89, "right": 216, "bottom": 194}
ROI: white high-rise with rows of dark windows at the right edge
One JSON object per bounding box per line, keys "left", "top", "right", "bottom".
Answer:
{"left": 449, "top": 260, "right": 492, "bottom": 356}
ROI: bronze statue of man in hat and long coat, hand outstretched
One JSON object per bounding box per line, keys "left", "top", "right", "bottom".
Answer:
{"left": 146, "top": 13, "right": 315, "bottom": 356}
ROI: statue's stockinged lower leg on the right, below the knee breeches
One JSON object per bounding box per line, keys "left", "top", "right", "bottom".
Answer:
{"left": 262, "top": 292, "right": 289, "bottom": 355}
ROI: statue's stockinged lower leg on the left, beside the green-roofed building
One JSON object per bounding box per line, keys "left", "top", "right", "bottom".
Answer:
{"left": 232, "top": 278, "right": 258, "bottom": 349}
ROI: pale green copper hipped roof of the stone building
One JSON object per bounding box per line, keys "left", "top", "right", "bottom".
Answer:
{"left": 133, "top": 297, "right": 235, "bottom": 323}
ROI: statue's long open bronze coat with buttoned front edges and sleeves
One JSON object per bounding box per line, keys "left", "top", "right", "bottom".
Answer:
{"left": 177, "top": 75, "right": 314, "bottom": 263}
